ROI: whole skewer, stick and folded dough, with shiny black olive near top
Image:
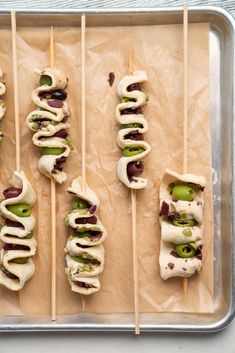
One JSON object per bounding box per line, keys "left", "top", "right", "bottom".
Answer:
{"left": 27, "top": 27, "right": 71, "bottom": 321}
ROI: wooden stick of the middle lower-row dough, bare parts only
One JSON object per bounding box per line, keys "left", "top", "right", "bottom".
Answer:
{"left": 81, "top": 14, "right": 86, "bottom": 312}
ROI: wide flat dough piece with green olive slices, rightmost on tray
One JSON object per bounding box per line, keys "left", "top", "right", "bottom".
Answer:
{"left": 159, "top": 169, "right": 206, "bottom": 280}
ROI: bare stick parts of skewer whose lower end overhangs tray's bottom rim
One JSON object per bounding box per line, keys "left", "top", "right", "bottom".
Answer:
{"left": 128, "top": 41, "right": 140, "bottom": 335}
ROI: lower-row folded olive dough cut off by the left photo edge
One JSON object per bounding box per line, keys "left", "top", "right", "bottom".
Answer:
{"left": 0, "top": 171, "right": 37, "bottom": 291}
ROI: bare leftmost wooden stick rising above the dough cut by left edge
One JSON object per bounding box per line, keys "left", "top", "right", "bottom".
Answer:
{"left": 11, "top": 11, "right": 20, "bottom": 171}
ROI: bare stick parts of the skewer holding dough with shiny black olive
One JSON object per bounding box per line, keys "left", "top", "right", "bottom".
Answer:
{"left": 50, "top": 27, "right": 56, "bottom": 321}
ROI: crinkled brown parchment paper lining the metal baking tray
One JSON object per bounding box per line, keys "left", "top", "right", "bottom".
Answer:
{"left": 0, "top": 20, "right": 214, "bottom": 315}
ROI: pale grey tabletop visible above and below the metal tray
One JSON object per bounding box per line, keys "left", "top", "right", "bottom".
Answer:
{"left": 0, "top": 0, "right": 235, "bottom": 353}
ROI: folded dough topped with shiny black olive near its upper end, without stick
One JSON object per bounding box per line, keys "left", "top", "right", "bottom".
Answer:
{"left": 27, "top": 68, "right": 71, "bottom": 183}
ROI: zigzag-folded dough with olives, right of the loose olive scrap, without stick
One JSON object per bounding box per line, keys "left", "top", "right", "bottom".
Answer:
{"left": 116, "top": 71, "right": 151, "bottom": 189}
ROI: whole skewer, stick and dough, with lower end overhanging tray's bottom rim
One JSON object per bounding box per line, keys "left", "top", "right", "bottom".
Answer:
{"left": 116, "top": 42, "right": 151, "bottom": 334}
